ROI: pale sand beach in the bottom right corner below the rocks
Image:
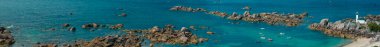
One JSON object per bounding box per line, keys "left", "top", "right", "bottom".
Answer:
{"left": 343, "top": 38, "right": 380, "bottom": 47}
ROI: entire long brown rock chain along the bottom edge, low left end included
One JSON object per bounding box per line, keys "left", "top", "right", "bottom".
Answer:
{"left": 36, "top": 25, "right": 208, "bottom": 47}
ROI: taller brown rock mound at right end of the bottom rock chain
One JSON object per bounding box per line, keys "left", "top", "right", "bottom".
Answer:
{"left": 138, "top": 25, "right": 208, "bottom": 45}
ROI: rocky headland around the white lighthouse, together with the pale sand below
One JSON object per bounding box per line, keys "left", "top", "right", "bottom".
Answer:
{"left": 309, "top": 15, "right": 380, "bottom": 47}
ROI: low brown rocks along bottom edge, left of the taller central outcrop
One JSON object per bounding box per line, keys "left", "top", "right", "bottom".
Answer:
{"left": 35, "top": 34, "right": 144, "bottom": 47}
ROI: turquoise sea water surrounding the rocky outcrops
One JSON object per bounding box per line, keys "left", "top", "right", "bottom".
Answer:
{"left": 0, "top": 0, "right": 380, "bottom": 47}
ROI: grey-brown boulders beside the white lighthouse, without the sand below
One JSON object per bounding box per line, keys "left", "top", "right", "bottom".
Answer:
{"left": 309, "top": 18, "right": 378, "bottom": 39}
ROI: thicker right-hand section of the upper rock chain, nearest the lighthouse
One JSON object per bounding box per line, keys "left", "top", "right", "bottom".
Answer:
{"left": 242, "top": 12, "right": 307, "bottom": 26}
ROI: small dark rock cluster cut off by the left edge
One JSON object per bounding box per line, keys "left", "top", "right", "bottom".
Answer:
{"left": 0, "top": 27, "right": 15, "bottom": 47}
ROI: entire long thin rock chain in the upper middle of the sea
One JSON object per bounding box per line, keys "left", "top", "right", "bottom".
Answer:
{"left": 170, "top": 6, "right": 308, "bottom": 26}
